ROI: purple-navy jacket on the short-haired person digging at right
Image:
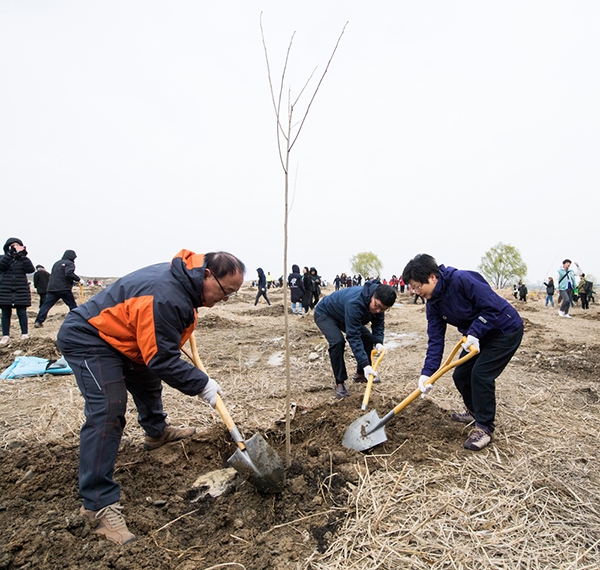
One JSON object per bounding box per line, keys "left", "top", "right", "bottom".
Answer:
{"left": 421, "top": 265, "right": 523, "bottom": 376}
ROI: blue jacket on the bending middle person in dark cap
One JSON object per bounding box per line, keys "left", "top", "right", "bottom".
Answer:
{"left": 315, "top": 281, "right": 385, "bottom": 368}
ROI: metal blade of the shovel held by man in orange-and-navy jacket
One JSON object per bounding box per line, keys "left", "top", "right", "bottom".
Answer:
{"left": 227, "top": 433, "right": 285, "bottom": 493}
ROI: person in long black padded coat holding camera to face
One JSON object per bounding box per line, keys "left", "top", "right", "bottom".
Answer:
{"left": 0, "top": 238, "right": 35, "bottom": 345}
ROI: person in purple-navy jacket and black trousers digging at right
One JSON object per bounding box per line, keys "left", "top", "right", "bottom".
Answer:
{"left": 402, "top": 254, "right": 523, "bottom": 451}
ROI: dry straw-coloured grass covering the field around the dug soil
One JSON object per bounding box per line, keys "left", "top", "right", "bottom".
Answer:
{"left": 0, "top": 284, "right": 600, "bottom": 570}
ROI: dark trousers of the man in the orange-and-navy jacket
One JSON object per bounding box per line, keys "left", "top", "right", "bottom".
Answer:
{"left": 56, "top": 313, "right": 167, "bottom": 511}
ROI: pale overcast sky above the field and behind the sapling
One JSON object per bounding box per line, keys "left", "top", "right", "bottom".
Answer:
{"left": 0, "top": 0, "right": 600, "bottom": 282}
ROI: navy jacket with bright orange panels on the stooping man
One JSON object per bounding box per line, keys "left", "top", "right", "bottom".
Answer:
{"left": 58, "top": 249, "right": 208, "bottom": 396}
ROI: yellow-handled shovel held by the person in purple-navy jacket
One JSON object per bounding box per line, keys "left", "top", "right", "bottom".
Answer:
{"left": 342, "top": 337, "right": 479, "bottom": 451}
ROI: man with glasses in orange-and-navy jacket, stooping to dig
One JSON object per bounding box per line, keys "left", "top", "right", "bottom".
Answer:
{"left": 57, "top": 250, "right": 245, "bottom": 544}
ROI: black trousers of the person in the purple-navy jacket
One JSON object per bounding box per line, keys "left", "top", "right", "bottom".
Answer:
{"left": 452, "top": 327, "right": 523, "bottom": 432}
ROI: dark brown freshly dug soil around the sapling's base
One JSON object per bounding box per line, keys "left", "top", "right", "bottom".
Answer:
{"left": 0, "top": 398, "right": 464, "bottom": 570}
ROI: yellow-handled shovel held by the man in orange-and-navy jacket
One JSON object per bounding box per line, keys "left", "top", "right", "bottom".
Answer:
{"left": 190, "top": 333, "right": 285, "bottom": 493}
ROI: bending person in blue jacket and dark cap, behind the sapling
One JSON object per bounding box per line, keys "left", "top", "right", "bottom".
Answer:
{"left": 314, "top": 280, "right": 396, "bottom": 399}
